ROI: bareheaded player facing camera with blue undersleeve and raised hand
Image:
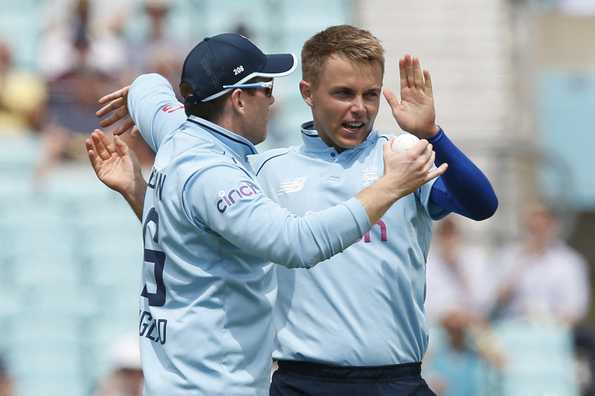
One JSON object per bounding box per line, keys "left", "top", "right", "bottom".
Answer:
{"left": 253, "top": 26, "right": 497, "bottom": 396}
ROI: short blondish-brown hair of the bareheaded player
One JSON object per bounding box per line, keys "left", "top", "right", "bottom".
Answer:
{"left": 302, "top": 25, "right": 384, "bottom": 86}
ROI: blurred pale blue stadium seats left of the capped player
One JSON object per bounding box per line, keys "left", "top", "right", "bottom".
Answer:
{"left": 0, "top": 137, "right": 142, "bottom": 396}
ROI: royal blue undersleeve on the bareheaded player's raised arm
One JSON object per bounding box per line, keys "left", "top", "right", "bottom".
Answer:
{"left": 429, "top": 129, "right": 498, "bottom": 220}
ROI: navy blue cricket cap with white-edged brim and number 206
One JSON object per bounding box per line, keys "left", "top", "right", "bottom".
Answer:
{"left": 182, "top": 33, "right": 296, "bottom": 103}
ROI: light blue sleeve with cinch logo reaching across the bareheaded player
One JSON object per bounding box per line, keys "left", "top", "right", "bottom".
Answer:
{"left": 182, "top": 164, "right": 370, "bottom": 268}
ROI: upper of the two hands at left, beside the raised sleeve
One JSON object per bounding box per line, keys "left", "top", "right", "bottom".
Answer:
{"left": 95, "top": 85, "right": 138, "bottom": 136}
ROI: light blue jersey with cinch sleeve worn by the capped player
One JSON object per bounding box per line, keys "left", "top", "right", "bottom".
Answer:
{"left": 128, "top": 75, "right": 369, "bottom": 396}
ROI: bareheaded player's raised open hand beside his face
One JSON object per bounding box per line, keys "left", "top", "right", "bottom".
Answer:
{"left": 384, "top": 55, "right": 438, "bottom": 139}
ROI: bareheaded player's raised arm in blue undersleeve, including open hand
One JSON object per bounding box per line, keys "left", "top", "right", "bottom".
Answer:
{"left": 384, "top": 55, "right": 498, "bottom": 220}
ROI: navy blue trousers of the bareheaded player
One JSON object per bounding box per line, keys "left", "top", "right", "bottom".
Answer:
{"left": 270, "top": 361, "right": 436, "bottom": 396}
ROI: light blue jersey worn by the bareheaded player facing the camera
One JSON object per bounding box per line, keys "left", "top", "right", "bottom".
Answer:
{"left": 251, "top": 123, "right": 441, "bottom": 366}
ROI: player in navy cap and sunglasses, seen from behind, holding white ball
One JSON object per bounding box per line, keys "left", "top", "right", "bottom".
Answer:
{"left": 87, "top": 34, "right": 447, "bottom": 396}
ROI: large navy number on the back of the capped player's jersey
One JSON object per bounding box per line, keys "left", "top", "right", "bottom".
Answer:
{"left": 141, "top": 208, "right": 165, "bottom": 307}
